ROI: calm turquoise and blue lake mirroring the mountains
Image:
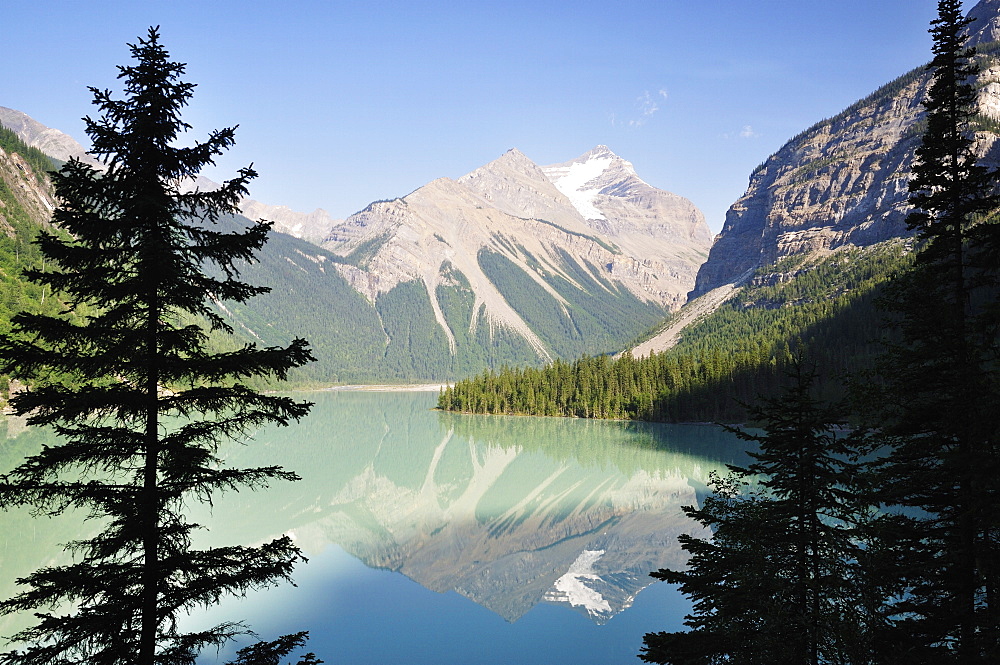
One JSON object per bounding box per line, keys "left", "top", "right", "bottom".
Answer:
{"left": 0, "top": 391, "right": 745, "bottom": 665}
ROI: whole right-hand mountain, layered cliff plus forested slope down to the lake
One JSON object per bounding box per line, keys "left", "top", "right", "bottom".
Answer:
{"left": 439, "top": 0, "right": 1000, "bottom": 421}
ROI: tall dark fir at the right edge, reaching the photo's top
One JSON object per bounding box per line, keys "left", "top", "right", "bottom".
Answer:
{"left": 873, "top": 0, "right": 1000, "bottom": 664}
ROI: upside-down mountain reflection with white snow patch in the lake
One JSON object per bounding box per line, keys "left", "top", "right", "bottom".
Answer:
{"left": 0, "top": 391, "right": 743, "bottom": 644}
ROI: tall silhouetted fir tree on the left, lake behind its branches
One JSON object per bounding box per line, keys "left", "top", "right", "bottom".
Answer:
{"left": 0, "top": 28, "right": 315, "bottom": 665}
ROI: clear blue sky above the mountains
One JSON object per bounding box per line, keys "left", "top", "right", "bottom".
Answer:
{"left": 0, "top": 0, "right": 974, "bottom": 231}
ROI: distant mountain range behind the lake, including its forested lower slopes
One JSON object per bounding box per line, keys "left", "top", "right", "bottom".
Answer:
{"left": 2, "top": 109, "right": 710, "bottom": 382}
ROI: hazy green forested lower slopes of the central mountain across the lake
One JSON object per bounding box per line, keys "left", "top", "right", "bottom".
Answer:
{"left": 166, "top": 210, "right": 665, "bottom": 385}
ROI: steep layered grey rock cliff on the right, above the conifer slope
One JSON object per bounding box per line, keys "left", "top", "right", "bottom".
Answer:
{"left": 690, "top": 0, "right": 1000, "bottom": 298}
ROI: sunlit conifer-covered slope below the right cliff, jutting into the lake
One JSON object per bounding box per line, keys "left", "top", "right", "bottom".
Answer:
{"left": 439, "top": 240, "right": 912, "bottom": 421}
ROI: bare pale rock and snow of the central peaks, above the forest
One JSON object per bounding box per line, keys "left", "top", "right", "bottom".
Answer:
{"left": 322, "top": 146, "right": 710, "bottom": 360}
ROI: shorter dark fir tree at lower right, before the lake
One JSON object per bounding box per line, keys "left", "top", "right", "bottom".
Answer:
{"left": 640, "top": 361, "right": 871, "bottom": 665}
